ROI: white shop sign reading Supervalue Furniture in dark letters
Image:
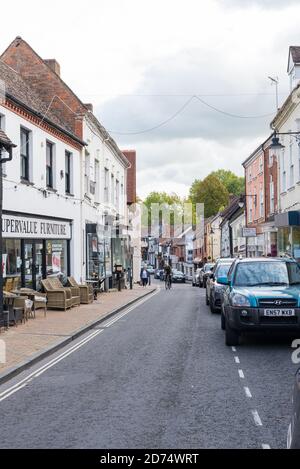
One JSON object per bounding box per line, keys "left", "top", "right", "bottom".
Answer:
{"left": 2, "top": 214, "right": 71, "bottom": 239}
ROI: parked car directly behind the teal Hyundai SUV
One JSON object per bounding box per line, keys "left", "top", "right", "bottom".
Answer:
{"left": 206, "top": 260, "right": 233, "bottom": 313}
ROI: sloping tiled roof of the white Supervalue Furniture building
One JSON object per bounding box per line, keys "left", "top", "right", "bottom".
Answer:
{"left": 0, "top": 60, "right": 77, "bottom": 138}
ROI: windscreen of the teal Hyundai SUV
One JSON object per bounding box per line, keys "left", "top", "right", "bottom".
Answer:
{"left": 234, "top": 261, "right": 299, "bottom": 287}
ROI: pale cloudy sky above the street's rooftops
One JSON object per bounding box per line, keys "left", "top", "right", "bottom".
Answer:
{"left": 0, "top": 0, "right": 300, "bottom": 198}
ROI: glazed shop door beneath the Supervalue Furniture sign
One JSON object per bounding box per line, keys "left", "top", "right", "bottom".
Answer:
{"left": 23, "top": 240, "right": 45, "bottom": 290}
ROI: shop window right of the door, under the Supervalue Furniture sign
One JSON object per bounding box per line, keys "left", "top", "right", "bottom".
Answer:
{"left": 46, "top": 239, "right": 68, "bottom": 284}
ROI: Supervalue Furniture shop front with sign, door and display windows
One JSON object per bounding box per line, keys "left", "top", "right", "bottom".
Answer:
{"left": 2, "top": 212, "right": 72, "bottom": 290}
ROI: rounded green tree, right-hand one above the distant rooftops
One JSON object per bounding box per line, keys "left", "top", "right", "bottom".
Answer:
{"left": 190, "top": 173, "right": 229, "bottom": 218}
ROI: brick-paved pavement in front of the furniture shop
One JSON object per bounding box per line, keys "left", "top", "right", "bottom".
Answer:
{"left": 0, "top": 285, "right": 153, "bottom": 383}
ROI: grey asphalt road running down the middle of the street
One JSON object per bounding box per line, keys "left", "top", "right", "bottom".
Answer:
{"left": 0, "top": 282, "right": 295, "bottom": 449}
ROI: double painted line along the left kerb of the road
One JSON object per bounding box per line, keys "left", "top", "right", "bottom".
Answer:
{"left": 0, "top": 290, "right": 158, "bottom": 402}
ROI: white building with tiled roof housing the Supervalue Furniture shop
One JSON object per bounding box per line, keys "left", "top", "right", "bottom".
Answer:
{"left": 0, "top": 61, "right": 85, "bottom": 289}
